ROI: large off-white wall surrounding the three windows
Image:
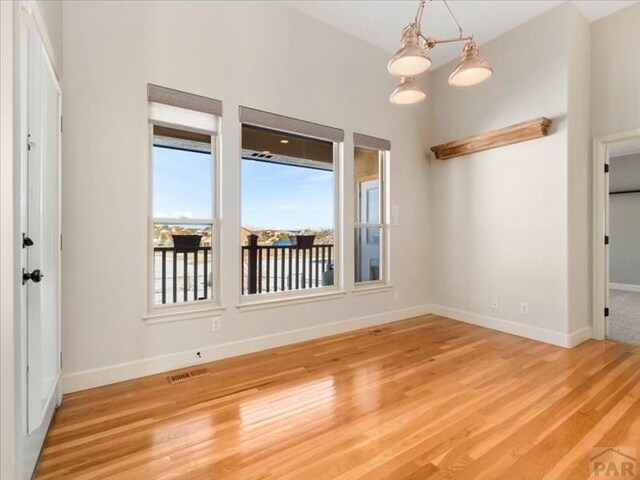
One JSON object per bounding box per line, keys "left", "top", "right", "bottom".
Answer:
{"left": 63, "top": 2, "right": 432, "bottom": 390}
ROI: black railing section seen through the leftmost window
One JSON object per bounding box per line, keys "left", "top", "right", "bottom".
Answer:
{"left": 153, "top": 247, "right": 212, "bottom": 304}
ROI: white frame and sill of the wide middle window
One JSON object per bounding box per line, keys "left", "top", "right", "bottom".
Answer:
{"left": 236, "top": 137, "right": 347, "bottom": 311}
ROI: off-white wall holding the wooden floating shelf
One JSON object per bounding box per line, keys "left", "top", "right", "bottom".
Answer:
{"left": 430, "top": 3, "right": 589, "bottom": 345}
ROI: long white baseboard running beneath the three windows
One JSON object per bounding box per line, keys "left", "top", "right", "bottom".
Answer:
{"left": 62, "top": 305, "right": 431, "bottom": 393}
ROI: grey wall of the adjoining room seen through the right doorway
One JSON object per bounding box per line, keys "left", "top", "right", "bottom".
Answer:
{"left": 609, "top": 154, "right": 640, "bottom": 288}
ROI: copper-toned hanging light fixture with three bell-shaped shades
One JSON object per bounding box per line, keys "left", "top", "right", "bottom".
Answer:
{"left": 387, "top": 0, "right": 493, "bottom": 105}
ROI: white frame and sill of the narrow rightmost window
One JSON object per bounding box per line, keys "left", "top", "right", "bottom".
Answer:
{"left": 353, "top": 145, "right": 392, "bottom": 286}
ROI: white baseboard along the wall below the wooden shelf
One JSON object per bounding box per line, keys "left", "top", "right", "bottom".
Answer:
{"left": 431, "top": 305, "right": 591, "bottom": 348}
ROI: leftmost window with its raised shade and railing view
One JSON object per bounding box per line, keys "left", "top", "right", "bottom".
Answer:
{"left": 149, "top": 86, "right": 219, "bottom": 310}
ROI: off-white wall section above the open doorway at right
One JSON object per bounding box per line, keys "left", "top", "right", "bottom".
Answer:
{"left": 591, "top": 3, "right": 640, "bottom": 137}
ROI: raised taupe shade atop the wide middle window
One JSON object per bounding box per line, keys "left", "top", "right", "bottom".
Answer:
{"left": 240, "top": 107, "right": 344, "bottom": 142}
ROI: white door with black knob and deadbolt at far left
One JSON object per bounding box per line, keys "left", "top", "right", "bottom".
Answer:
{"left": 22, "top": 24, "right": 61, "bottom": 434}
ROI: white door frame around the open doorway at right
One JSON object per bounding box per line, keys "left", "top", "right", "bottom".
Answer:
{"left": 592, "top": 130, "right": 640, "bottom": 340}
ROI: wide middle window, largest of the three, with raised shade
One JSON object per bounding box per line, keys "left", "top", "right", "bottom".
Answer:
{"left": 241, "top": 107, "right": 342, "bottom": 295}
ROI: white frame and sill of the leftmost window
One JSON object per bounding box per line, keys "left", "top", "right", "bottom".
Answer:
{"left": 142, "top": 113, "right": 225, "bottom": 325}
